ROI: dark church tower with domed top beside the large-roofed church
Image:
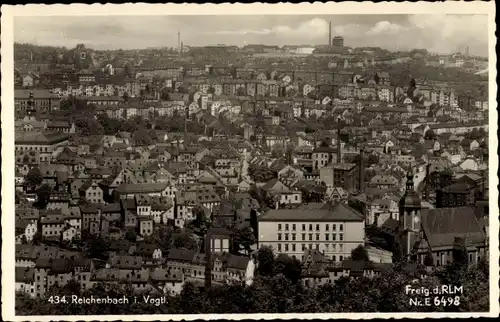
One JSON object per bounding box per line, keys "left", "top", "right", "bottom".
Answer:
{"left": 396, "top": 168, "right": 422, "bottom": 257}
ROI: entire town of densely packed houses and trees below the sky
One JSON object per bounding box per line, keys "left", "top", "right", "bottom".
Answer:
{"left": 14, "top": 36, "right": 489, "bottom": 315}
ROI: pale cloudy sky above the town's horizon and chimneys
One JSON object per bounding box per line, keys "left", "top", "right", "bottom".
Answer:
{"left": 14, "top": 14, "right": 488, "bottom": 56}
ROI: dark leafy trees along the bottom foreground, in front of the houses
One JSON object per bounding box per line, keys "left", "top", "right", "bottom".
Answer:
{"left": 16, "top": 247, "right": 489, "bottom": 315}
